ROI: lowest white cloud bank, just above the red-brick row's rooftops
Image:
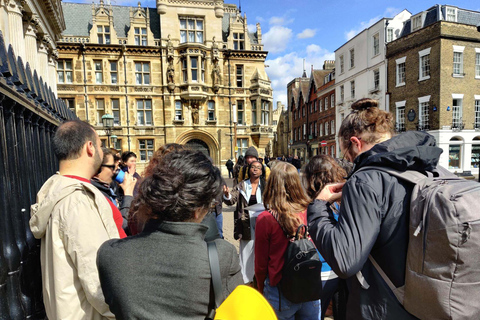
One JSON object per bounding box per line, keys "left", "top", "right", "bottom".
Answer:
{"left": 265, "top": 44, "right": 335, "bottom": 105}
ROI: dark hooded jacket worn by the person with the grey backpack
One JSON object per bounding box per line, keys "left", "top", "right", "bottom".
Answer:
{"left": 308, "top": 131, "right": 442, "bottom": 320}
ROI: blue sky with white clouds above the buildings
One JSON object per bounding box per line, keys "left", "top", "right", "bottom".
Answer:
{"left": 67, "top": 0, "right": 480, "bottom": 106}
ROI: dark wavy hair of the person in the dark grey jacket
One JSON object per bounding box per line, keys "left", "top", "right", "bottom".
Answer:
{"left": 133, "top": 150, "right": 221, "bottom": 222}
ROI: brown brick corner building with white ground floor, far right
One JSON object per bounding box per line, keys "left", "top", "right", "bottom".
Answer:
{"left": 387, "top": 5, "right": 480, "bottom": 173}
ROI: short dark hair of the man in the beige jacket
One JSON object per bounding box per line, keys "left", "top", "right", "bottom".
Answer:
{"left": 53, "top": 120, "right": 97, "bottom": 161}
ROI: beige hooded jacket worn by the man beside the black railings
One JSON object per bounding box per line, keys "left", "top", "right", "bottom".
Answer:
{"left": 30, "top": 174, "right": 119, "bottom": 320}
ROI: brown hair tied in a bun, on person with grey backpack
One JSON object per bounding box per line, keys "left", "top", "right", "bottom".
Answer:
{"left": 338, "top": 98, "right": 394, "bottom": 148}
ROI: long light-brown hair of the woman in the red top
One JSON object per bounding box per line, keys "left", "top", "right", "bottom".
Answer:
{"left": 263, "top": 162, "right": 310, "bottom": 235}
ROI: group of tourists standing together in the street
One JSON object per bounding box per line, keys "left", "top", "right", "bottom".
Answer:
{"left": 30, "top": 99, "right": 456, "bottom": 320}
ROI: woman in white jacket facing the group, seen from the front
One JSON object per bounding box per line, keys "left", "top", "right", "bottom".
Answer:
{"left": 223, "top": 161, "right": 266, "bottom": 283}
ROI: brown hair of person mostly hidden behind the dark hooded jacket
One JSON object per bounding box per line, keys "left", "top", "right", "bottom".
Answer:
{"left": 303, "top": 154, "right": 347, "bottom": 200}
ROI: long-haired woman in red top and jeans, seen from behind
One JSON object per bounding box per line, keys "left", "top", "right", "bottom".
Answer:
{"left": 255, "top": 161, "right": 321, "bottom": 320}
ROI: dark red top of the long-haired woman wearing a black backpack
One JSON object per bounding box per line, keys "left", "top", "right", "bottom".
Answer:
{"left": 255, "top": 210, "right": 307, "bottom": 293}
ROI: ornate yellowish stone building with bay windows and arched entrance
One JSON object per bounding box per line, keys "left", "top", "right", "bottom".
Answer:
{"left": 58, "top": 0, "right": 273, "bottom": 171}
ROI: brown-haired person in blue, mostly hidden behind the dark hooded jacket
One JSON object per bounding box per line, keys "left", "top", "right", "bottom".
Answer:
{"left": 303, "top": 155, "right": 347, "bottom": 320}
